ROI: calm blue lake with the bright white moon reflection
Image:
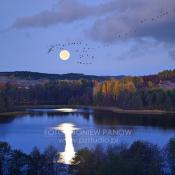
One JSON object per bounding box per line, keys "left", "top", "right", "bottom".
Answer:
{"left": 0, "top": 108, "right": 175, "bottom": 164}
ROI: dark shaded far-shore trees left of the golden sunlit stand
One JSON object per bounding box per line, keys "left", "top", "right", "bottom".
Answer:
{"left": 0, "top": 80, "right": 93, "bottom": 112}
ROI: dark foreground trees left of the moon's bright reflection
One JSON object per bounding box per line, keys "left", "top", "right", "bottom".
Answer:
{"left": 0, "top": 142, "right": 59, "bottom": 175}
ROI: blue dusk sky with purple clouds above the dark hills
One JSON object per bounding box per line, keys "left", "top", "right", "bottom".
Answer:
{"left": 0, "top": 0, "right": 175, "bottom": 75}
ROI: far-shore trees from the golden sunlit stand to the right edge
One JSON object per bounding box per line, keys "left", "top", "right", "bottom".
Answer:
{"left": 93, "top": 77, "right": 175, "bottom": 110}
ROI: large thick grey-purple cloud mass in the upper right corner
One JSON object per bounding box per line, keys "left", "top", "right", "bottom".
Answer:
{"left": 88, "top": 0, "right": 175, "bottom": 42}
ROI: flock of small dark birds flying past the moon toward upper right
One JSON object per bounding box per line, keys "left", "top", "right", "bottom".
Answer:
{"left": 48, "top": 8, "right": 175, "bottom": 65}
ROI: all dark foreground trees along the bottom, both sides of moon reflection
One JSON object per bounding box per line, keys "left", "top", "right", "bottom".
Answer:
{"left": 0, "top": 139, "right": 175, "bottom": 175}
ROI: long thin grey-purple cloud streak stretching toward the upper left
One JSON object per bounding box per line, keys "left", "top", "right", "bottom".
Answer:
{"left": 12, "top": 0, "right": 119, "bottom": 28}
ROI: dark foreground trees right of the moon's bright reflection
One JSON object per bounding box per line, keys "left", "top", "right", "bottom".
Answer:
{"left": 70, "top": 139, "right": 175, "bottom": 175}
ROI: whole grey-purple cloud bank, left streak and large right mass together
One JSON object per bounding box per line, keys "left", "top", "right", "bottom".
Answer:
{"left": 12, "top": 0, "right": 175, "bottom": 42}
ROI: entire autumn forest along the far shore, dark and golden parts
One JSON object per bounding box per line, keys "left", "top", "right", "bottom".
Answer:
{"left": 0, "top": 70, "right": 175, "bottom": 112}
